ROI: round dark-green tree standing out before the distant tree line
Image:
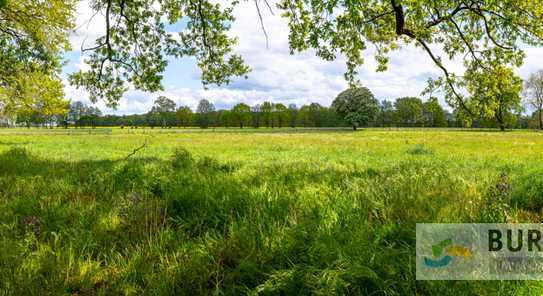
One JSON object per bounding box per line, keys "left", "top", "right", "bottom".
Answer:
{"left": 332, "top": 87, "right": 379, "bottom": 130}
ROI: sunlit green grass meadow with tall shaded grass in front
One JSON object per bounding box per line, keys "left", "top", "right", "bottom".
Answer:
{"left": 0, "top": 129, "right": 543, "bottom": 295}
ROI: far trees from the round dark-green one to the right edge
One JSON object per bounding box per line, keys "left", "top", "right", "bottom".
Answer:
{"left": 332, "top": 69, "right": 543, "bottom": 131}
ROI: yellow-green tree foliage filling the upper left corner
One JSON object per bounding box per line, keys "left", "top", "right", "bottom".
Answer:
{"left": 0, "top": 0, "right": 75, "bottom": 111}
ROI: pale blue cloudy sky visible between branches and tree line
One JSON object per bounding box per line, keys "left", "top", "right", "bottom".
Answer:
{"left": 63, "top": 1, "right": 543, "bottom": 115}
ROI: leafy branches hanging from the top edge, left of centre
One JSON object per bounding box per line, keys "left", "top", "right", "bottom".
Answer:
{"left": 71, "top": 0, "right": 253, "bottom": 106}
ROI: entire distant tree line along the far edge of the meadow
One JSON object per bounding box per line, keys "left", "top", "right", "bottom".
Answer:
{"left": 0, "top": 69, "right": 543, "bottom": 130}
